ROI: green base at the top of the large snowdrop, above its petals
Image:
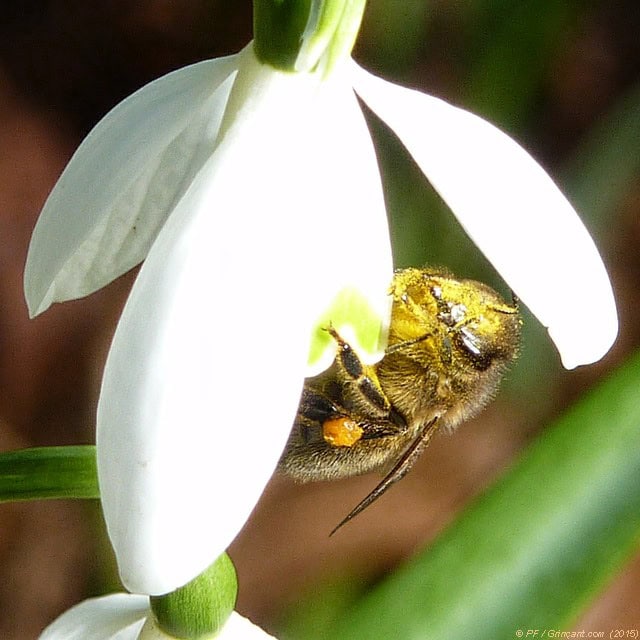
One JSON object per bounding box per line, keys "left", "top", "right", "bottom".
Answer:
{"left": 253, "top": 0, "right": 366, "bottom": 74}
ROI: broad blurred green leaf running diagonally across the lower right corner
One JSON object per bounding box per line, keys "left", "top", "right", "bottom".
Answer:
{"left": 326, "top": 354, "right": 640, "bottom": 640}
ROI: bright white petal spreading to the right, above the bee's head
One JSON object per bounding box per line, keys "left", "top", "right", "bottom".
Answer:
{"left": 352, "top": 64, "right": 618, "bottom": 368}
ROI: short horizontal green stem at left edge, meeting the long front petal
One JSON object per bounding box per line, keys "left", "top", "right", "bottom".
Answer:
{"left": 0, "top": 445, "right": 100, "bottom": 502}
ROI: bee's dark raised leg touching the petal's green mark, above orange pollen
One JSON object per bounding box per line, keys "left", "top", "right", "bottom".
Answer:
{"left": 328, "top": 327, "right": 391, "bottom": 418}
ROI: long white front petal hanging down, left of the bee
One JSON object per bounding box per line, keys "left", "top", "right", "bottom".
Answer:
{"left": 98, "top": 45, "right": 336, "bottom": 594}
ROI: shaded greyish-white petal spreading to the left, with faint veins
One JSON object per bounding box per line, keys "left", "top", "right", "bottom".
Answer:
{"left": 25, "top": 56, "right": 236, "bottom": 315}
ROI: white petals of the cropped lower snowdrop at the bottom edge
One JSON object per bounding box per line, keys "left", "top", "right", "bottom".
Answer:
{"left": 40, "top": 593, "right": 273, "bottom": 640}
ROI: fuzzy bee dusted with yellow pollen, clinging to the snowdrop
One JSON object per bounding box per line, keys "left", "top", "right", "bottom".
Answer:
{"left": 278, "top": 268, "right": 521, "bottom": 534}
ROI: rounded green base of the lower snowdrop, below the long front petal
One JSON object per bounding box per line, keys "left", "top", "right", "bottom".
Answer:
{"left": 151, "top": 553, "right": 238, "bottom": 640}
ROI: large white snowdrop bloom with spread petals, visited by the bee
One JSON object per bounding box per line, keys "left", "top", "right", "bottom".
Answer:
{"left": 25, "top": 3, "right": 617, "bottom": 594}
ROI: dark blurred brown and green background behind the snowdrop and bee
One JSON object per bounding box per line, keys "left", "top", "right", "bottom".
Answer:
{"left": 0, "top": 0, "right": 640, "bottom": 640}
